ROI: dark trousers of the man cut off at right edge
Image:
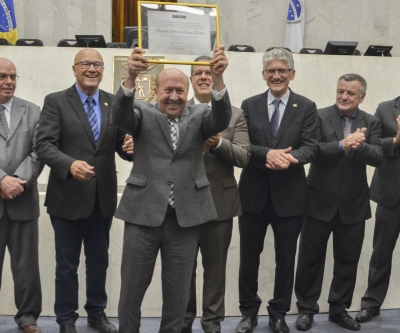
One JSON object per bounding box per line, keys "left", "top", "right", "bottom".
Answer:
{"left": 361, "top": 203, "right": 400, "bottom": 309}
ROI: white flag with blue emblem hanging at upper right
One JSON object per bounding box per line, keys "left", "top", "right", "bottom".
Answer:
{"left": 282, "top": 0, "right": 305, "bottom": 52}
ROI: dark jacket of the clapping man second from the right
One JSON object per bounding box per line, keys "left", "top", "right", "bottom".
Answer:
{"left": 307, "top": 105, "right": 383, "bottom": 224}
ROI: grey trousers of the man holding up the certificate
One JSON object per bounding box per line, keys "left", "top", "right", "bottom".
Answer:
{"left": 118, "top": 214, "right": 200, "bottom": 333}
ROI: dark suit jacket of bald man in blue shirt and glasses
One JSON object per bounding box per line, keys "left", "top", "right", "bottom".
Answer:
{"left": 36, "top": 85, "right": 129, "bottom": 220}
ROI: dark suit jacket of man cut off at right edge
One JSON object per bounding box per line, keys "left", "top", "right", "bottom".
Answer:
{"left": 371, "top": 97, "right": 400, "bottom": 207}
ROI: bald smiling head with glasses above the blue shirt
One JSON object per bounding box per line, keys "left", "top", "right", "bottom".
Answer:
{"left": 72, "top": 49, "right": 104, "bottom": 96}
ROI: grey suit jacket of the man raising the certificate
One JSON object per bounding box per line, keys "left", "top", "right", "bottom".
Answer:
{"left": 111, "top": 88, "right": 231, "bottom": 227}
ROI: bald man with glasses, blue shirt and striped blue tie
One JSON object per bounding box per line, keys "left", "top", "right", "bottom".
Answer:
{"left": 36, "top": 49, "right": 132, "bottom": 333}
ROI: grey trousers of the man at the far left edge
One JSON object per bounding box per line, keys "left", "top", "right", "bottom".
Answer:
{"left": 0, "top": 209, "right": 42, "bottom": 327}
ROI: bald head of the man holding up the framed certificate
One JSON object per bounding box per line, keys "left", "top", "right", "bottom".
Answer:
{"left": 155, "top": 68, "right": 189, "bottom": 119}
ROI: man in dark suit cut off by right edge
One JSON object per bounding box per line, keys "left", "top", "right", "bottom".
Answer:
{"left": 356, "top": 97, "right": 400, "bottom": 322}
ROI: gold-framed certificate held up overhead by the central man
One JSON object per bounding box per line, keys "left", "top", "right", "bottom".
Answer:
{"left": 138, "top": 1, "right": 220, "bottom": 66}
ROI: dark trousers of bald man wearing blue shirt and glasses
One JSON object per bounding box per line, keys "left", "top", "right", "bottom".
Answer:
{"left": 50, "top": 200, "right": 112, "bottom": 325}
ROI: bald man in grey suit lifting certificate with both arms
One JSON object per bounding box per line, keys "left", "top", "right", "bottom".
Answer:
{"left": 112, "top": 46, "right": 231, "bottom": 333}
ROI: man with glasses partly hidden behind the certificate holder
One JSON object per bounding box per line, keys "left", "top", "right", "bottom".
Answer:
{"left": 182, "top": 56, "right": 250, "bottom": 333}
